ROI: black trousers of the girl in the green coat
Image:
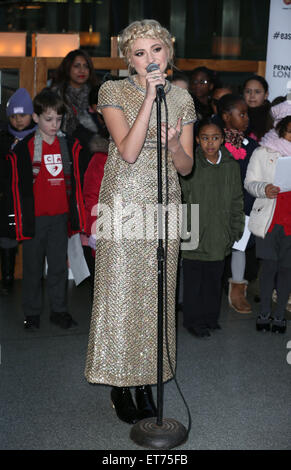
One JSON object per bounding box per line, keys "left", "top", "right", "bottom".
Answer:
{"left": 183, "top": 259, "right": 224, "bottom": 331}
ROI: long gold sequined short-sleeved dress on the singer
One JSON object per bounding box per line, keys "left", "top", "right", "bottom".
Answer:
{"left": 85, "top": 76, "right": 195, "bottom": 387}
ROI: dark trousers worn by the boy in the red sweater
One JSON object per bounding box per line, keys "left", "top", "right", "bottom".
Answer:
{"left": 22, "top": 214, "right": 68, "bottom": 316}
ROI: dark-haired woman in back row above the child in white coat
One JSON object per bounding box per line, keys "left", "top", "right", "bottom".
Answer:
{"left": 243, "top": 75, "right": 273, "bottom": 142}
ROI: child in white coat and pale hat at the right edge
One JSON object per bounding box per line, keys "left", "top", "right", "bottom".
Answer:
{"left": 245, "top": 107, "right": 291, "bottom": 333}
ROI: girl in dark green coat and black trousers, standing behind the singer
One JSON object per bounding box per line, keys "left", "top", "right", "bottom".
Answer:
{"left": 181, "top": 118, "right": 245, "bottom": 337}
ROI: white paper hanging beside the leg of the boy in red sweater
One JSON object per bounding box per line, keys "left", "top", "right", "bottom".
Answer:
{"left": 68, "top": 233, "right": 90, "bottom": 286}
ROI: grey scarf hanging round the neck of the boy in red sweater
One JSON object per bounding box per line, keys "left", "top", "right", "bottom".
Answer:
{"left": 32, "top": 129, "right": 72, "bottom": 196}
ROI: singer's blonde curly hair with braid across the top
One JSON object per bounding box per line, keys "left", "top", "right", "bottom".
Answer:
{"left": 118, "top": 20, "right": 174, "bottom": 66}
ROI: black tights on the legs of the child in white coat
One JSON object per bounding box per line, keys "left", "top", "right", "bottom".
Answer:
{"left": 260, "top": 259, "right": 291, "bottom": 319}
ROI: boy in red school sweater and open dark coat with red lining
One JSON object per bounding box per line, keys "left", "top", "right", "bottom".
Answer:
{"left": 7, "top": 89, "right": 84, "bottom": 330}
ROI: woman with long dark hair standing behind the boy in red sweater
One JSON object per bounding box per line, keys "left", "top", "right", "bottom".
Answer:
{"left": 52, "top": 49, "right": 97, "bottom": 135}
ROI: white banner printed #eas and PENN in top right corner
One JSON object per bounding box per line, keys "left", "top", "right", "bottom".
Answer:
{"left": 266, "top": 0, "right": 291, "bottom": 101}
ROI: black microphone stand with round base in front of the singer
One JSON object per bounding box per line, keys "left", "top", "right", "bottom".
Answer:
{"left": 130, "top": 88, "right": 187, "bottom": 449}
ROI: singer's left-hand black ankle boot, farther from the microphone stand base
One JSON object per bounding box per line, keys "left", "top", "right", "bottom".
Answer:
{"left": 111, "top": 387, "right": 140, "bottom": 424}
